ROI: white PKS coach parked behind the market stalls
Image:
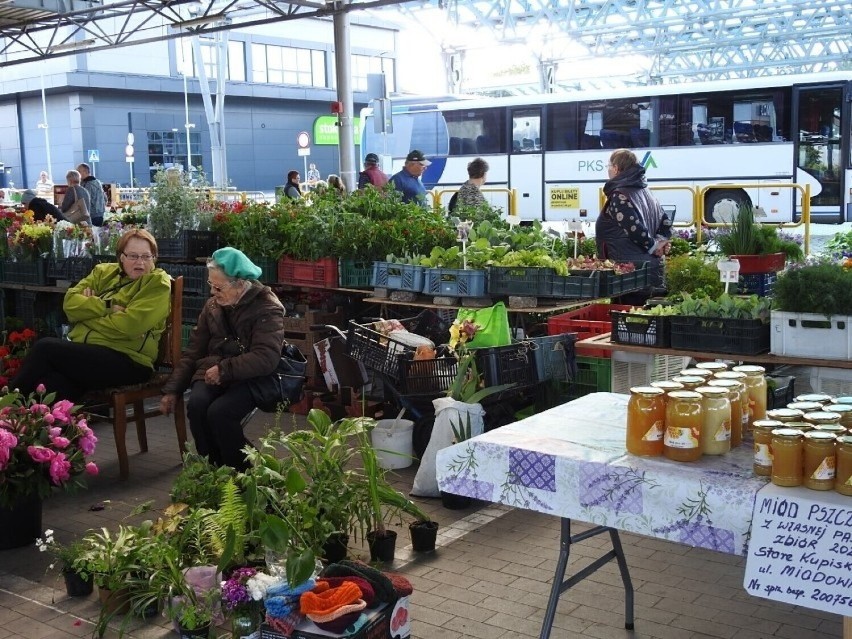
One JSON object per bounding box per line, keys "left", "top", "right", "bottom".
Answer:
{"left": 361, "top": 71, "right": 852, "bottom": 223}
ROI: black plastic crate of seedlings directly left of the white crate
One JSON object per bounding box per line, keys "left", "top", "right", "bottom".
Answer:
{"left": 671, "top": 315, "right": 769, "bottom": 355}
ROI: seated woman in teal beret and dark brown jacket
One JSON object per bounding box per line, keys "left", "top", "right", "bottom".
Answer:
{"left": 160, "top": 247, "right": 284, "bottom": 470}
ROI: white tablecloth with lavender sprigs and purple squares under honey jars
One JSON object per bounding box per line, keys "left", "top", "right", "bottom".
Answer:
{"left": 437, "top": 393, "right": 767, "bottom": 554}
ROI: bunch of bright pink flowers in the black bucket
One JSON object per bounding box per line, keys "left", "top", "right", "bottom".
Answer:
{"left": 0, "top": 385, "right": 98, "bottom": 507}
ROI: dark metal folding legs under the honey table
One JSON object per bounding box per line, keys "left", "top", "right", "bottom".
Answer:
{"left": 539, "top": 517, "right": 633, "bottom": 639}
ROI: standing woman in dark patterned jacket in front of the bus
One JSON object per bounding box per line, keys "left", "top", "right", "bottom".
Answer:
{"left": 595, "top": 149, "right": 672, "bottom": 287}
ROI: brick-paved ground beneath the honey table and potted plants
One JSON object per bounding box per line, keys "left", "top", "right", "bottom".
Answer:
{"left": 0, "top": 404, "right": 842, "bottom": 639}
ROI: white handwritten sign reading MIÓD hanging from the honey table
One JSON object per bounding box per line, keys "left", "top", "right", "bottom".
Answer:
{"left": 743, "top": 484, "right": 852, "bottom": 616}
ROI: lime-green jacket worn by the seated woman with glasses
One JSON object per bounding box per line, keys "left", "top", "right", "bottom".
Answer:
{"left": 63, "top": 263, "right": 171, "bottom": 370}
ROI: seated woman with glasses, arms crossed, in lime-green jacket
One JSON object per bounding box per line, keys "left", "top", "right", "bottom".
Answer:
{"left": 9, "top": 229, "right": 171, "bottom": 401}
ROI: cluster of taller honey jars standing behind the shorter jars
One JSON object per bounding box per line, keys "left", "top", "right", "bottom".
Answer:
{"left": 626, "top": 362, "right": 766, "bottom": 461}
